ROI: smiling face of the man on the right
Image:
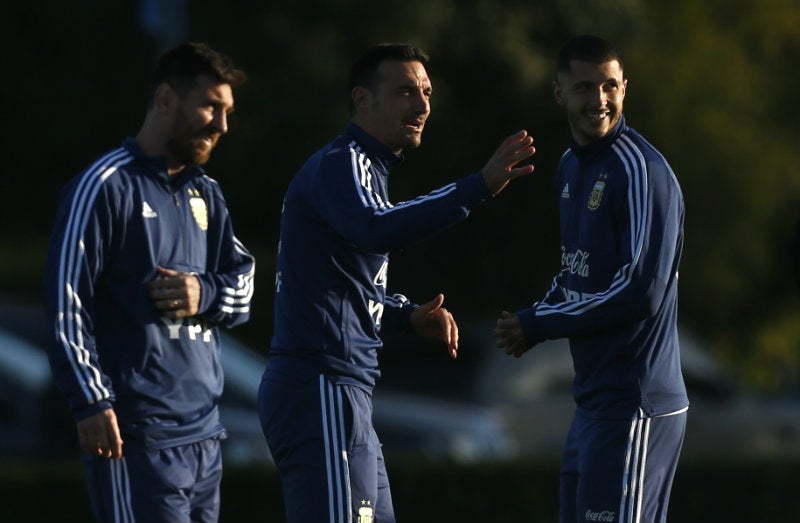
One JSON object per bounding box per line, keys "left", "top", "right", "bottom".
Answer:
{"left": 553, "top": 60, "right": 628, "bottom": 145}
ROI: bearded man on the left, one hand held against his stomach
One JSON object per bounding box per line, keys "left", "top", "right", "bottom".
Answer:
{"left": 45, "top": 43, "right": 255, "bottom": 523}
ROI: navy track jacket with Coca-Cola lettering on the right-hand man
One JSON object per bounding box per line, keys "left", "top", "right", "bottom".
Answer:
{"left": 517, "top": 117, "right": 688, "bottom": 419}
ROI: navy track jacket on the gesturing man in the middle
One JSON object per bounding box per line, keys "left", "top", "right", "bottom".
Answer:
{"left": 268, "top": 123, "right": 491, "bottom": 390}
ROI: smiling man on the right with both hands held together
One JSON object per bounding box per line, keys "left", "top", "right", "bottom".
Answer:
{"left": 495, "top": 35, "right": 689, "bottom": 523}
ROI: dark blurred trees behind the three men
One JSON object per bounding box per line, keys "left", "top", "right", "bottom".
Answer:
{"left": 0, "top": 0, "right": 800, "bottom": 391}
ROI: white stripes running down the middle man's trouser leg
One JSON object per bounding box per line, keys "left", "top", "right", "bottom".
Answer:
{"left": 319, "top": 375, "right": 352, "bottom": 523}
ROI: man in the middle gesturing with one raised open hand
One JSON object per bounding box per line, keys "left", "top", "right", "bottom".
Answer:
{"left": 259, "top": 44, "right": 534, "bottom": 523}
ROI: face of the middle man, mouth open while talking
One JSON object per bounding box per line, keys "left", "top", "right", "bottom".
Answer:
{"left": 353, "top": 60, "right": 432, "bottom": 153}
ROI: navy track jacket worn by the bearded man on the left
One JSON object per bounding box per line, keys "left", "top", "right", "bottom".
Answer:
{"left": 45, "top": 138, "right": 255, "bottom": 450}
